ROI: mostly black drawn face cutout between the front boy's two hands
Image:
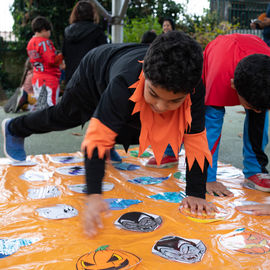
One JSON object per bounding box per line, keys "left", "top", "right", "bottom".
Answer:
{"left": 118, "top": 212, "right": 162, "bottom": 232}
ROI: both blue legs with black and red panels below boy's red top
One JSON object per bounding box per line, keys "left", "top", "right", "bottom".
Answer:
{"left": 205, "top": 106, "right": 268, "bottom": 182}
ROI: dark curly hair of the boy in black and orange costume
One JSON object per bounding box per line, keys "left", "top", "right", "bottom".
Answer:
{"left": 143, "top": 31, "right": 203, "bottom": 93}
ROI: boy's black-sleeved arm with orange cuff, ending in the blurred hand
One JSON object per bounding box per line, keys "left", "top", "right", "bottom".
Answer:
{"left": 82, "top": 78, "right": 132, "bottom": 237}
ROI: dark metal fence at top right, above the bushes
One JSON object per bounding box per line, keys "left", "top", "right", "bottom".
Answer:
{"left": 210, "top": 0, "right": 270, "bottom": 29}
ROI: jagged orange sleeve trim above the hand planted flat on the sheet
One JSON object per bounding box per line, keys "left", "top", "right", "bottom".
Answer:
{"left": 184, "top": 130, "right": 212, "bottom": 171}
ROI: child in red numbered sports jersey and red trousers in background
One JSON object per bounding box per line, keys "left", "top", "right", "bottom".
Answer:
{"left": 27, "top": 16, "right": 63, "bottom": 106}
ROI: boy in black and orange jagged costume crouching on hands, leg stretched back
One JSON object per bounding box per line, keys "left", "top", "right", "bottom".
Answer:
{"left": 2, "top": 31, "right": 213, "bottom": 236}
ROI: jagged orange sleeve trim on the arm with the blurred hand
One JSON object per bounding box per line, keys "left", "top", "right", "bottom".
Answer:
{"left": 81, "top": 117, "right": 117, "bottom": 159}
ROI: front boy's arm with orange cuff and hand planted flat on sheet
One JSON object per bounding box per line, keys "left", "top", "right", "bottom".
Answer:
{"left": 182, "top": 81, "right": 217, "bottom": 215}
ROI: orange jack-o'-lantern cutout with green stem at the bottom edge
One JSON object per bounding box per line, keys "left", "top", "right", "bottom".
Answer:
{"left": 76, "top": 246, "right": 141, "bottom": 270}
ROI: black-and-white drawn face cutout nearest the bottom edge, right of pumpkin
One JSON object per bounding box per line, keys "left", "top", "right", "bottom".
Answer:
{"left": 152, "top": 236, "right": 206, "bottom": 263}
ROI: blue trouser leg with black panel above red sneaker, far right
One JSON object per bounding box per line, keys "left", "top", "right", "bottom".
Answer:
{"left": 243, "top": 110, "right": 268, "bottom": 178}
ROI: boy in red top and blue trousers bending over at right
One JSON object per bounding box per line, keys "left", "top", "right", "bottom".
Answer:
{"left": 203, "top": 34, "right": 270, "bottom": 196}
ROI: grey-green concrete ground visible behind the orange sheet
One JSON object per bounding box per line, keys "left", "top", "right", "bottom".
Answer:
{"left": 0, "top": 106, "right": 270, "bottom": 171}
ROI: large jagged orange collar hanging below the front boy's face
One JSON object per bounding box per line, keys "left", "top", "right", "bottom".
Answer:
{"left": 129, "top": 69, "right": 191, "bottom": 164}
